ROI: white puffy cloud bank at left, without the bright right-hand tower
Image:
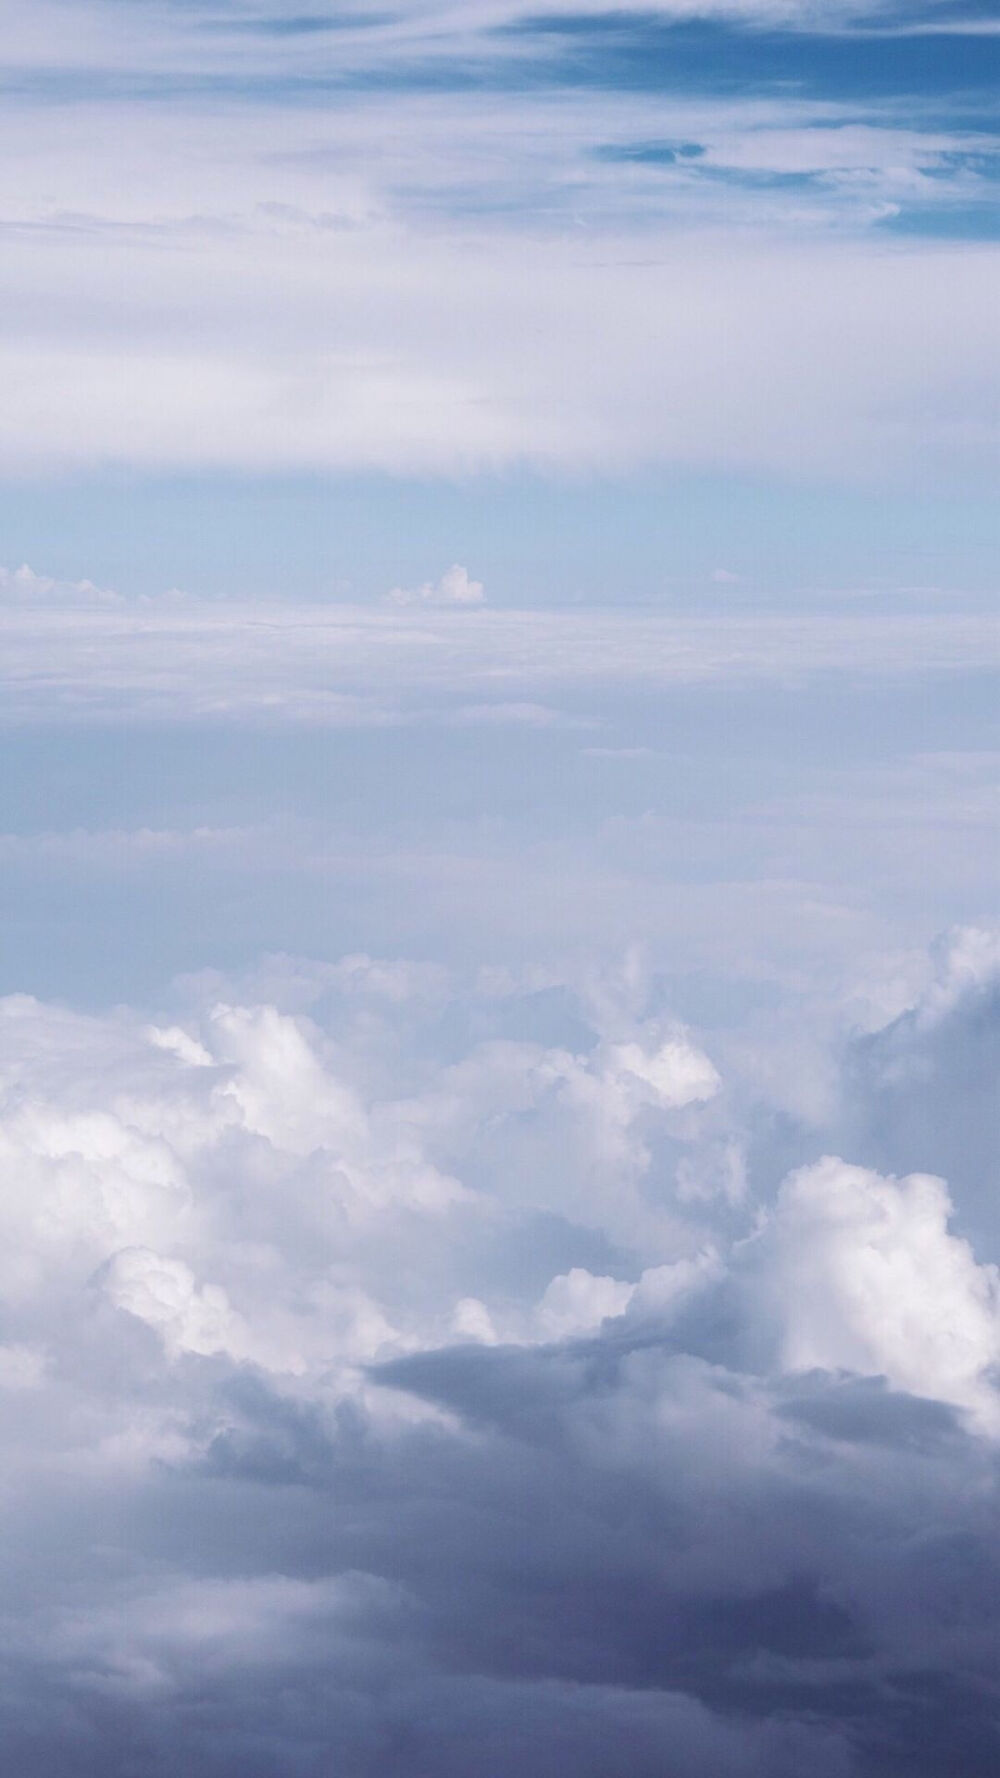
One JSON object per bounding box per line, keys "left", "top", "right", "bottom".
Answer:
{"left": 0, "top": 958, "right": 719, "bottom": 1378}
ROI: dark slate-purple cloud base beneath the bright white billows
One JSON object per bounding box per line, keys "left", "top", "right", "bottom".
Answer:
{"left": 5, "top": 1335, "right": 1000, "bottom": 1778}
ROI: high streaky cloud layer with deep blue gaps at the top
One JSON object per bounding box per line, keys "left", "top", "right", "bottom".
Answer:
{"left": 0, "top": 0, "right": 1000, "bottom": 491}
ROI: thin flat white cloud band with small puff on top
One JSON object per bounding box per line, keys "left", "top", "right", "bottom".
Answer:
{"left": 0, "top": 579, "right": 1000, "bottom": 727}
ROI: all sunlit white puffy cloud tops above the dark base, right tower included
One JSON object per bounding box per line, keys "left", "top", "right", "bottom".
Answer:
{"left": 0, "top": 941, "right": 998, "bottom": 1417}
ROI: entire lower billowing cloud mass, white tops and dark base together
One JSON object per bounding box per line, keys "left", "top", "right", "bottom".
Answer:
{"left": 0, "top": 930, "right": 1000, "bottom": 1778}
